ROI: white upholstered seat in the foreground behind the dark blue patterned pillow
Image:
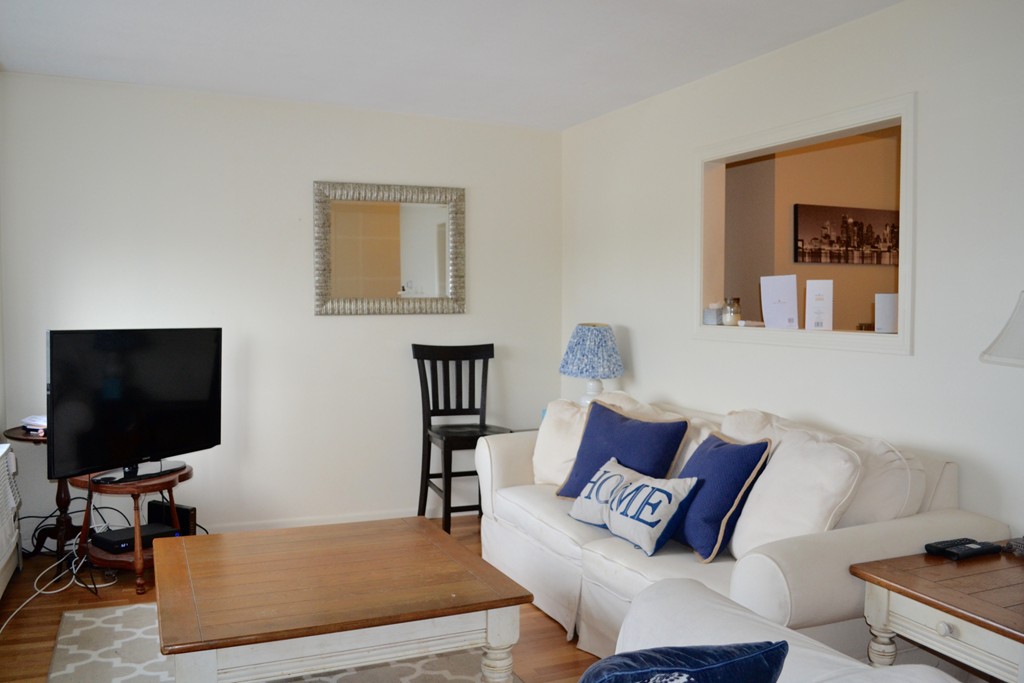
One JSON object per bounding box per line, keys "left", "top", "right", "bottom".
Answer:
{"left": 616, "top": 579, "right": 957, "bottom": 683}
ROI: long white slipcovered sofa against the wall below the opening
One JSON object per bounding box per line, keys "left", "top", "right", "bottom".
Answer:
{"left": 475, "top": 392, "right": 1010, "bottom": 657}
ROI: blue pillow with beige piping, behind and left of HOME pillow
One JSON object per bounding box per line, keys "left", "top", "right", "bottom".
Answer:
{"left": 558, "top": 400, "right": 687, "bottom": 498}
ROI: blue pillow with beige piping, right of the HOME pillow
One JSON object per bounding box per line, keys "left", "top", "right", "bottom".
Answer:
{"left": 676, "top": 434, "right": 771, "bottom": 562}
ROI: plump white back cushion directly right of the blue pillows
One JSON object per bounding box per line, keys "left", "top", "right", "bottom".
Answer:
{"left": 729, "top": 431, "right": 861, "bottom": 559}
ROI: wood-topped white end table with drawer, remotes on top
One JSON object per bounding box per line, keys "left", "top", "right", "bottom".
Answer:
{"left": 850, "top": 553, "right": 1024, "bottom": 683}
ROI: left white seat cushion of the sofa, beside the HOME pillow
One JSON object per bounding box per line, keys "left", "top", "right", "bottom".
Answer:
{"left": 495, "top": 484, "right": 611, "bottom": 563}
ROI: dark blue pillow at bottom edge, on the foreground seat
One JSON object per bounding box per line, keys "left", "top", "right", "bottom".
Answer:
{"left": 580, "top": 640, "right": 790, "bottom": 683}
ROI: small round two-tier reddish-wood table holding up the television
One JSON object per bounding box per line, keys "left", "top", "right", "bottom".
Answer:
{"left": 68, "top": 463, "right": 193, "bottom": 595}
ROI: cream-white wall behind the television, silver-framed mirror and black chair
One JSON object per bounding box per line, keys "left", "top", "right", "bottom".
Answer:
{"left": 0, "top": 74, "right": 560, "bottom": 530}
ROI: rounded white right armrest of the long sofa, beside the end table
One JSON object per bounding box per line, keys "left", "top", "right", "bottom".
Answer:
{"left": 729, "top": 510, "right": 1010, "bottom": 629}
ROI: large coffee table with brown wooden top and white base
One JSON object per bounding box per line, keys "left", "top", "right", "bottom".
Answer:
{"left": 154, "top": 517, "right": 532, "bottom": 683}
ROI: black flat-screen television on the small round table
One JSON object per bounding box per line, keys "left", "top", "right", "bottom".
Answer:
{"left": 46, "top": 328, "right": 221, "bottom": 481}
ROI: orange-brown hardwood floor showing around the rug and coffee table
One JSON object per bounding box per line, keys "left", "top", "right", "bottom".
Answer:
{"left": 0, "top": 515, "right": 597, "bottom": 683}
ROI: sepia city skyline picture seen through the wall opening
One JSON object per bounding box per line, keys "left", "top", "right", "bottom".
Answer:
{"left": 793, "top": 204, "right": 899, "bottom": 265}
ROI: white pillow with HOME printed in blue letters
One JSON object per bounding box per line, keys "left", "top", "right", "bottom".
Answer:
{"left": 569, "top": 458, "right": 698, "bottom": 555}
